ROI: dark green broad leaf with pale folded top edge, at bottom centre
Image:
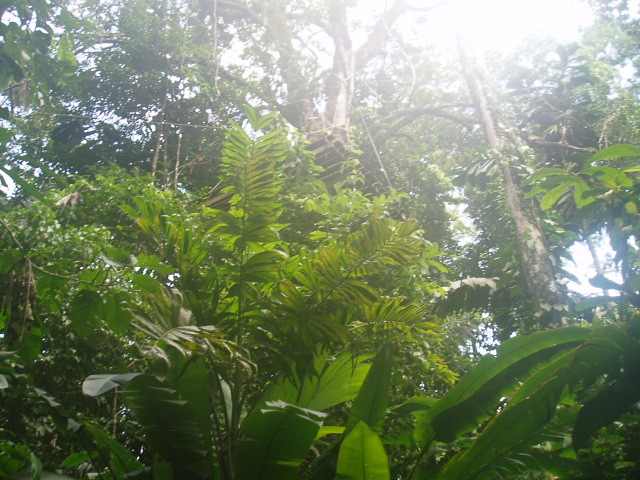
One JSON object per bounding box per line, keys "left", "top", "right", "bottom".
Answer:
{"left": 236, "top": 402, "right": 326, "bottom": 480}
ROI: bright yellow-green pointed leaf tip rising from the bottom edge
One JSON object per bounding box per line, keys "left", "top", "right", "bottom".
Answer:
{"left": 336, "top": 422, "right": 391, "bottom": 480}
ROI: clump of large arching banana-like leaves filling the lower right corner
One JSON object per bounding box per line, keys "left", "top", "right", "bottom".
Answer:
{"left": 396, "top": 320, "right": 640, "bottom": 479}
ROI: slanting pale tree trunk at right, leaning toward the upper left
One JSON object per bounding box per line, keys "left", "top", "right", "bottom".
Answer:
{"left": 458, "top": 35, "right": 567, "bottom": 328}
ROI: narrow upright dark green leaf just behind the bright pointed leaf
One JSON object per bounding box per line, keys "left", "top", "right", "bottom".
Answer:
{"left": 346, "top": 344, "right": 395, "bottom": 433}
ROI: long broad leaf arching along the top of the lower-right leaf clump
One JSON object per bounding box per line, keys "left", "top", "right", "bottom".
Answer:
{"left": 416, "top": 327, "right": 590, "bottom": 442}
